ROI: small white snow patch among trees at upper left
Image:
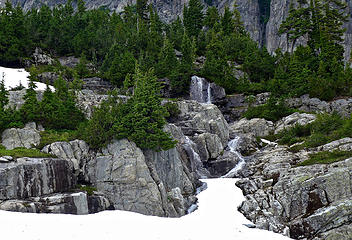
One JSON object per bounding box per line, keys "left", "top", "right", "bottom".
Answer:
{"left": 0, "top": 67, "right": 54, "bottom": 90}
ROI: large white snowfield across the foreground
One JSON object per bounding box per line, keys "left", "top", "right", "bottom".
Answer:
{"left": 0, "top": 178, "right": 289, "bottom": 240}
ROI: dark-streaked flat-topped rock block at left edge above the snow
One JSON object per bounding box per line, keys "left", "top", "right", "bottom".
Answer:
{"left": 0, "top": 158, "right": 76, "bottom": 200}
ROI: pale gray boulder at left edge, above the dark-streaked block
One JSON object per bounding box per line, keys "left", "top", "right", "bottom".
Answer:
{"left": 1, "top": 123, "right": 40, "bottom": 150}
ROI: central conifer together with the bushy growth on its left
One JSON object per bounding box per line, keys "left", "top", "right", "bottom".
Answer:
{"left": 79, "top": 68, "right": 175, "bottom": 150}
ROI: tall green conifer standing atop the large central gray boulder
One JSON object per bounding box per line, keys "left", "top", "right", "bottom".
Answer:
{"left": 114, "top": 67, "right": 175, "bottom": 151}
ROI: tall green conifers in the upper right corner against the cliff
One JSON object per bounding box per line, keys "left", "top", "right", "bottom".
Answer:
{"left": 278, "top": 0, "right": 349, "bottom": 100}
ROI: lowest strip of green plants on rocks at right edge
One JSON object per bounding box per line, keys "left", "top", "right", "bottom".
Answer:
{"left": 298, "top": 151, "right": 352, "bottom": 166}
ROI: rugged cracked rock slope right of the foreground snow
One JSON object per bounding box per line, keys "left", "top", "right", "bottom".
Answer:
{"left": 237, "top": 139, "right": 352, "bottom": 239}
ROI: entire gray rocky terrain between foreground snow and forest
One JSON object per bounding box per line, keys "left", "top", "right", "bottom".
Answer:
{"left": 0, "top": 77, "right": 352, "bottom": 239}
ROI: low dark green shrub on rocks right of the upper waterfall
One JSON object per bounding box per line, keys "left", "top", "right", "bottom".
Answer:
{"left": 243, "top": 97, "right": 295, "bottom": 121}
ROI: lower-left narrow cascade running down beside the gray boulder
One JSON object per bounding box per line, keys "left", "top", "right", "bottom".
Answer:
{"left": 183, "top": 136, "right": 210, "bottom": 178}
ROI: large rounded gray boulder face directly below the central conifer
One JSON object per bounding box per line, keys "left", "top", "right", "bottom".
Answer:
{"left": 85, "top": 139, "right": 165, "bottom": 216}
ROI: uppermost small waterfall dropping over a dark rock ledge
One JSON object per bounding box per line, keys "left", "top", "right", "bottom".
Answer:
{"left": 190, "top": 76, "right": 211, "bottom": 104}
